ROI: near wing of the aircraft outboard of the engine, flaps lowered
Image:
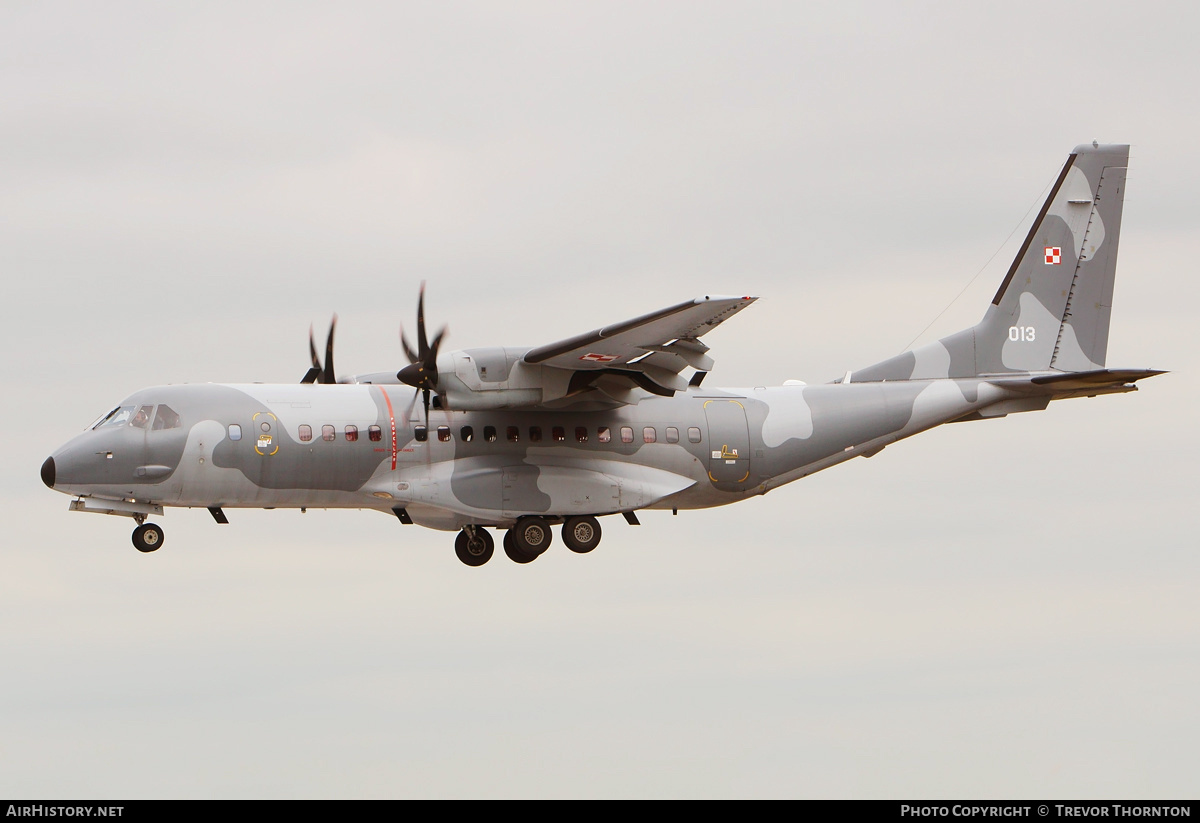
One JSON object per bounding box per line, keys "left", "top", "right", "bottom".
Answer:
{"left": 523, "top": 295, "right": 757, "bottom": 395}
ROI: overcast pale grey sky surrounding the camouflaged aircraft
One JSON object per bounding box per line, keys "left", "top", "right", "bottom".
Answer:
{"left": 0, "top": 1, "right": 1200, "bottom": 798}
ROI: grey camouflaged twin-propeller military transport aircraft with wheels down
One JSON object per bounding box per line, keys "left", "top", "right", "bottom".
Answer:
{"left": 42, "top": 143, "right": 1162, "bottom": 566}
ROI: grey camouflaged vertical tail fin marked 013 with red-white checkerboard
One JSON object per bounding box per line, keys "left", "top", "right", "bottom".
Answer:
{"left": 853, "top": 143, "right": 1129, "bottom": 383}
